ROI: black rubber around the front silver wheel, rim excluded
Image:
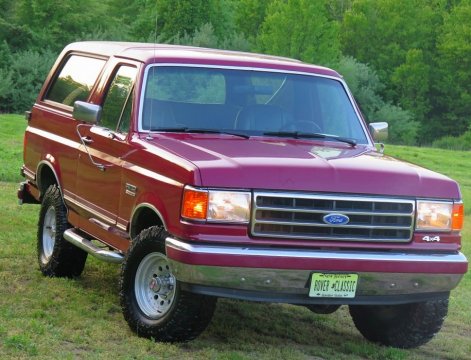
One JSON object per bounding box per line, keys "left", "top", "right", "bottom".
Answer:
{"left": 120, "top": 226, "right": 217, "bottom": 342}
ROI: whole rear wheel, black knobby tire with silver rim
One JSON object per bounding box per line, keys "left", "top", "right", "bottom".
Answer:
{"left": 37, "top": 185, "right": 88, "bottom": 278}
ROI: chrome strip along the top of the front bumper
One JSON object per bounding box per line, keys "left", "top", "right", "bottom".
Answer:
{"left": 165, "top": 237, "right": 467, "bottom": 263}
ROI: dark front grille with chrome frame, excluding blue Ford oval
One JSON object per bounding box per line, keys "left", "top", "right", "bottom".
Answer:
{"left": 251, "top": 192, "right": 415, "bottom": 242}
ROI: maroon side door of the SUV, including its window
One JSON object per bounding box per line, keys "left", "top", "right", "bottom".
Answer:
{"left": 76, "top": 64, "right": 137, "bottom": 246}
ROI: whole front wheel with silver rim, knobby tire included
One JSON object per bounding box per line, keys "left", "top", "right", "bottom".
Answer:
{"left": 120, "top": 226, "right": 217, "bottom": 342}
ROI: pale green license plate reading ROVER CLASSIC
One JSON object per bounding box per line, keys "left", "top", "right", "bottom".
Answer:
{"left": 309, "top": 273, "right": 358, "bottom": 298}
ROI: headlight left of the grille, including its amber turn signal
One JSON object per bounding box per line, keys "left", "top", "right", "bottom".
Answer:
{"left": 181, "top": 186, "right": 251, "bottom": 223}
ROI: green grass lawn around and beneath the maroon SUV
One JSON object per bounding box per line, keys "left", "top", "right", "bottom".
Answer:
{"left": 0, "top": 115, "right": 471, "bottom": 360}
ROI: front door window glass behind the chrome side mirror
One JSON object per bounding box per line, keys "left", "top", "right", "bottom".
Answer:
{"left": 101, "top": 65, "right": 137, "bottom": 133}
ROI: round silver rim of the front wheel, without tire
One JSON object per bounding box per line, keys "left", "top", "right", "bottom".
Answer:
{"left": 134, "top": 252, "right": 175, "bottom": 319}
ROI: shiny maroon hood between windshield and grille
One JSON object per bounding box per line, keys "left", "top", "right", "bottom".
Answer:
{"left": 150, "top": 134, "right": 460, "bottom": 199}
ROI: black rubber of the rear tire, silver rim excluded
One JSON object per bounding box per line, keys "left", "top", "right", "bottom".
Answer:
{"left": 37, "top": 185, "right": 88, "bottom": 278}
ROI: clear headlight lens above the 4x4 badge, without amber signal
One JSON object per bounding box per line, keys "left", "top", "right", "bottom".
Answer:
{"left": 416, "top": 200, "right": 453, "bottom": 231}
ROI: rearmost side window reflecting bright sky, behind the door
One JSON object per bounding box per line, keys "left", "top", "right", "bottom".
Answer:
{"left": 45, "top": 55, "right": 105, "bottom": 106}
